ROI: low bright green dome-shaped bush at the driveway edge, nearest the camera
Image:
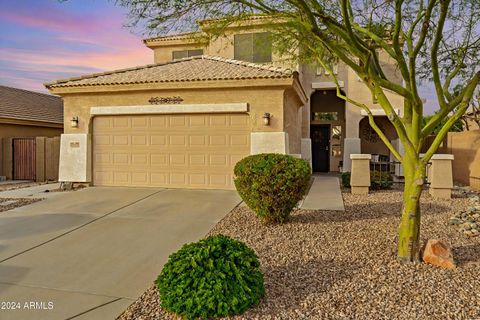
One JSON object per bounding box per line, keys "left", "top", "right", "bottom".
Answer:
{"left": 155, "top": 235, "right": 265, "bottom": 319}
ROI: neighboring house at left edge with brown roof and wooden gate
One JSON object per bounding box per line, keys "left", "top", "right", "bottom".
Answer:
{"left": 0, "top": 85, "right": 63, "bottom": 180}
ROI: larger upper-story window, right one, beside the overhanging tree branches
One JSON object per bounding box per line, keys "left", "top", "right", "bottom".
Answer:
{"left": 234, "top": 32, "right": 272, "bottom": 63}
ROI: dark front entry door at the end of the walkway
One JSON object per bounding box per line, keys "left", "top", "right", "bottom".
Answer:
{"left": 310, "top": 124, "right": 330, "bottom": 172}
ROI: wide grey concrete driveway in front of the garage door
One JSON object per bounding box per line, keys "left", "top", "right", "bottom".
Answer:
{"left": 0, "top": 187, "right": 240, "bottom": 319}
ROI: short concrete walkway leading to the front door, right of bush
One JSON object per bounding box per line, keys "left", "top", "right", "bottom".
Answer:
{"left": 300, "top": 175, "right": 345, "bottom": 211}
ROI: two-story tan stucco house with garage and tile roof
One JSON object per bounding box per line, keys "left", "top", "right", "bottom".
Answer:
{"left": 46, "top": 19, "right": 403, "bottom": 189}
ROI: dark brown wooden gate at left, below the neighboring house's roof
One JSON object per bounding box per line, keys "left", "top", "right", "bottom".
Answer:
{"left": 13, "top": 138, "right": 35, "bottom": 180}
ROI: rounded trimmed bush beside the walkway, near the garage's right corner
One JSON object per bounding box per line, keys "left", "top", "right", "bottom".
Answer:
{"left": 234, "top": 153, "right": 311, "bottom": 223}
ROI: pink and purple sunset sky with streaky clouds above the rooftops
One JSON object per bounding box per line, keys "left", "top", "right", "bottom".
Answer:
{"left": 0, "top": 0, "right": 436, "bottom": 112}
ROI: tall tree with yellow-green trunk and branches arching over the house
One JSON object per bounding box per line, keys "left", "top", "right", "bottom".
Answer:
{"left": 116, "top": 0, "right": 480, "bottom": 262}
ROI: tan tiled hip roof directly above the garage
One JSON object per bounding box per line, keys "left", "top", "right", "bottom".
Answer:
{"left": 45, "top": 56, "right": 296, "bottom": 89}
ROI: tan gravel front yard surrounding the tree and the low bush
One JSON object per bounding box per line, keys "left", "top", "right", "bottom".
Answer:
{"left": 119, "top": 191, "right": 480, "bottom": 320}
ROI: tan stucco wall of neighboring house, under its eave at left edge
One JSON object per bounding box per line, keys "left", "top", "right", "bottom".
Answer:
{"left": 0, "top": 122, "right": 63, "bottom": 176}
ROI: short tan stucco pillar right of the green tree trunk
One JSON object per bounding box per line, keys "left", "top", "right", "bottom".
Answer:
{"left": 428, "top": 154, "right": 454, "bottom": 199}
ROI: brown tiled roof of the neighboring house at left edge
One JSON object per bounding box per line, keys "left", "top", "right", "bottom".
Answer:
{"left": 0, "top": 85, "right": 63, "bottom": 123}
